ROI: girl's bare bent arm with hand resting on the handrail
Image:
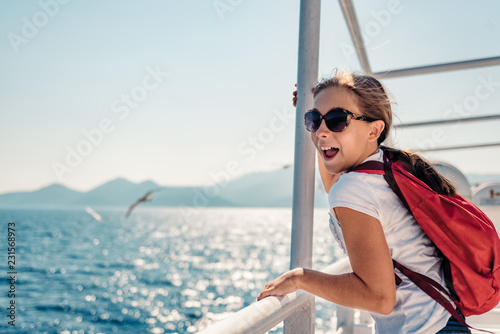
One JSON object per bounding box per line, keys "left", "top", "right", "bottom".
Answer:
{"left": 258, "top": 207, "right": 396, "bottom": 314}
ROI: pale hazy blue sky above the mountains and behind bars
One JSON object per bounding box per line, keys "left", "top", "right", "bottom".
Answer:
{"left": 0, "top": 0, "right": 500, "bottom": 193}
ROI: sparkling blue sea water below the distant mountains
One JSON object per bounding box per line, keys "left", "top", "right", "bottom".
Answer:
{"left": 0, "top": 207, "right": 344, "bottom": 334}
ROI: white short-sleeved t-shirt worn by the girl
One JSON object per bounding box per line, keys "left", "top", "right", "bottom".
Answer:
{"left": 328, "top": 150, "right": 450, "bottom": 334}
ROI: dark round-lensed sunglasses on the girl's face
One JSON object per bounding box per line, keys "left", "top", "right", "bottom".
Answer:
{"left": 304, "top": 108, "right": 375, "bottom": 132}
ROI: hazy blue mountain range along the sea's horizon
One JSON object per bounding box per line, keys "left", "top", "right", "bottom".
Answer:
{"left": 0, "top": 168, "right": 327, "bottom": 207}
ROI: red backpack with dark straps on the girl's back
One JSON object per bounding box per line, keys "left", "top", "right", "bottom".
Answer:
{"left": 351, "top": 150, "right": 500, "bottom": 326}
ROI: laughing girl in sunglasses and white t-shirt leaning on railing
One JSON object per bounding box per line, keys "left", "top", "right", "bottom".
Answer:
{"left": 258, "top": 72, "right": 470, "bottom": 334}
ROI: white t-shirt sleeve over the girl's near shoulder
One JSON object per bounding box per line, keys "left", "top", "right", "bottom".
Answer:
{"left": 328, "top": 173, "right": 380, "bottom": 221}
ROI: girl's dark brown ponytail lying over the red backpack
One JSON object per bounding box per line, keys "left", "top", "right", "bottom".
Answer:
{"left": 380, "top": 146, "right": 456, "bottom": 196}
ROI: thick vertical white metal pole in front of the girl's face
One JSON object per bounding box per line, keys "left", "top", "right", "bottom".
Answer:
{"left": 285, "top": 0, "right": 321, "bottom": 334}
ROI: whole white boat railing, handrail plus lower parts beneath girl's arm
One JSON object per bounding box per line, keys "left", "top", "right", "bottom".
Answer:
{"left": 199, "top": 258, "right": 371, "bottom": 334}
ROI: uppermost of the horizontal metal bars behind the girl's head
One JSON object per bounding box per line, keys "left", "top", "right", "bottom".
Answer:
{"left": 373, "top": 56, "right": 500, "bottom": 79}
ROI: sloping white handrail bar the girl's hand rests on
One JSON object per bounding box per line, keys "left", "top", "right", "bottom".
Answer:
{"left": 198, "top": 258, "right": 351, "bottom": 334}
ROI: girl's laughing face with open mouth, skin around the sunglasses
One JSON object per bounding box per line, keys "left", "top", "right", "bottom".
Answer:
{"left": 311, "top": 87, "right": 383, "bottom": 174}
